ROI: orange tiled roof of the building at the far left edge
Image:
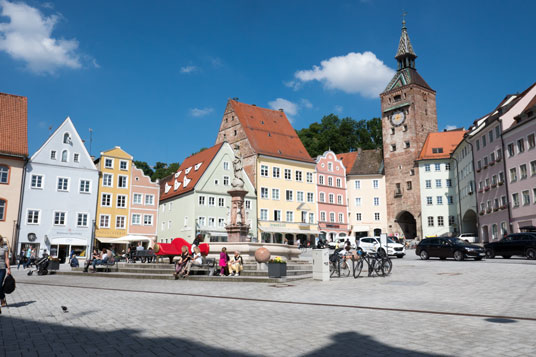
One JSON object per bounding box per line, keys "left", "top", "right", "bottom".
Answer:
{"left": 0, "top": 93, "right": 28, "bottom": 156}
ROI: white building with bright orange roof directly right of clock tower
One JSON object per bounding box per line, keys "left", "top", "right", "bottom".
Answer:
{"left": 417, "top": 130, "right": 465, "bottom": 237}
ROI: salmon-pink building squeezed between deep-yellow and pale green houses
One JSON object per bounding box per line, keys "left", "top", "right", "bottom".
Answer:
{"left": 128, "top": 165, "right": 160, "bottom": 238}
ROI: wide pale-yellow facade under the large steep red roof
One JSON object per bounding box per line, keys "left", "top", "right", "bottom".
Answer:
{"left": 256, "top": 155, "right": 319, "bottom": 244}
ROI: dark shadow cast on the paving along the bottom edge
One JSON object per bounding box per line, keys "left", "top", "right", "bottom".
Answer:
{"left": 0, "top": 316, "right": 444, "bottom": 357}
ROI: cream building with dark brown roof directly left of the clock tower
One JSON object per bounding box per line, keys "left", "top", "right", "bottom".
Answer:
{"left": 338, "top": 149, "right": 388, "bottom": 239}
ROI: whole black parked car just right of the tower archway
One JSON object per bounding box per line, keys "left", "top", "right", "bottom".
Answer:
{"left": 415, "top": 237, "right": 485, "bottom": 261}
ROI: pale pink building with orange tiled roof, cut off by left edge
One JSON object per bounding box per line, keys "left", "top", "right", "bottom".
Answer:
{"left": 0, "top": 93, "right": 28, "bottom": 254}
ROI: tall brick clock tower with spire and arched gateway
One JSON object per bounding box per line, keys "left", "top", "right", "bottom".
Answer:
{"left": 380, "top": 20, "right": 437, "bottom": 239}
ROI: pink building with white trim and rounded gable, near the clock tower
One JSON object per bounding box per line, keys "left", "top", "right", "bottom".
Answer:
{"left": 316, "top": 151, "right": 349, "bottom": 241}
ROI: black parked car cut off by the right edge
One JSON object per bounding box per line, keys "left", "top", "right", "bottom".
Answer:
{"left": 484, "top": 233, "right": 536, "bottom": 260}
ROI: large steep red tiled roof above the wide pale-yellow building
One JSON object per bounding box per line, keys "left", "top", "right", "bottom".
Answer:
{"left": 229, "top": 100, "right": 314, "bottom": 163}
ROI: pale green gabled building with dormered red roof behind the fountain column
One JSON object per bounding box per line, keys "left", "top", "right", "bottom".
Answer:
{"left": 158, "top": 143, "right": 257, "bottom": 243}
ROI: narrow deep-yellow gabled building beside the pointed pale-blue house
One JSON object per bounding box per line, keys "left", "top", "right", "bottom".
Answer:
{"left": 95, "top": 146, "right": 132, "bottom": 243}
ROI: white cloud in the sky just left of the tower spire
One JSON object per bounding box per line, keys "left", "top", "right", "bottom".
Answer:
{"left": 294, "top": 51, "right": 395, "bottom": 98}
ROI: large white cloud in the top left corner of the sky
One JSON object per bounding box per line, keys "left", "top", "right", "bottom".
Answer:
{"left": 0, "top": 0, "right": 82, "bottom": 73}
